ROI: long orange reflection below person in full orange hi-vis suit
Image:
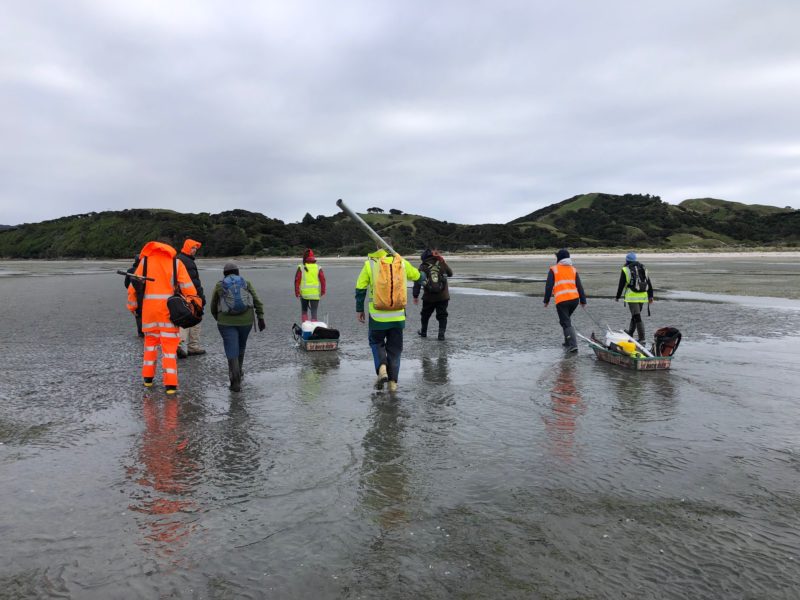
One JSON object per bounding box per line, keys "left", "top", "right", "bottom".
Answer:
{"left": 128, "top": 395, "right": 198, "bottom": 557}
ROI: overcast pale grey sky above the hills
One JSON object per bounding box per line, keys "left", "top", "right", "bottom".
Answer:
{"left": 0, "top": 0, "right": 800, "bottom": 224}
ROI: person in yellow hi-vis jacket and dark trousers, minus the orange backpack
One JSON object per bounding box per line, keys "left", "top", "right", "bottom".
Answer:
{"left": 356, "top": 240, "right": 420, "bottom": 392}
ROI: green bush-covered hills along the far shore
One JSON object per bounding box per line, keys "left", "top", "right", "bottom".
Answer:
{"left": 0, "top": 193, "right": 800, "bottom": 258}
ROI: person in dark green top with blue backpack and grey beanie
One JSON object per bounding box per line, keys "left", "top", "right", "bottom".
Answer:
{"left": 211, "top": 263, "right": 267, "bottom": 392}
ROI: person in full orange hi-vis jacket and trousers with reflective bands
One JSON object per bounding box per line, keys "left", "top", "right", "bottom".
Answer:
{"left": 128, "top": 242, "right": 197, "bottom": 394}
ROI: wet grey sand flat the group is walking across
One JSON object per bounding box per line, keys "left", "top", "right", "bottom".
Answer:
{"left": 0, "top": 253, "right": 800, "bottom": 599}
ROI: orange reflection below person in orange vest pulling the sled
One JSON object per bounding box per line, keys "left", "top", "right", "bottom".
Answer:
{"left": 542, "top": 358, "right": 586, "bottom": 462}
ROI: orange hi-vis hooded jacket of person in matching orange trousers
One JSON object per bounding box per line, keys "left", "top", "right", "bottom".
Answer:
{"left": 128, "top": 242, "right": 197, "bottom": 331}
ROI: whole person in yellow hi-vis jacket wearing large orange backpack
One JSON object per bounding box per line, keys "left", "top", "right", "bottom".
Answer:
{"left": 356, "top": 240, "right": 421, "bottom": 392}
